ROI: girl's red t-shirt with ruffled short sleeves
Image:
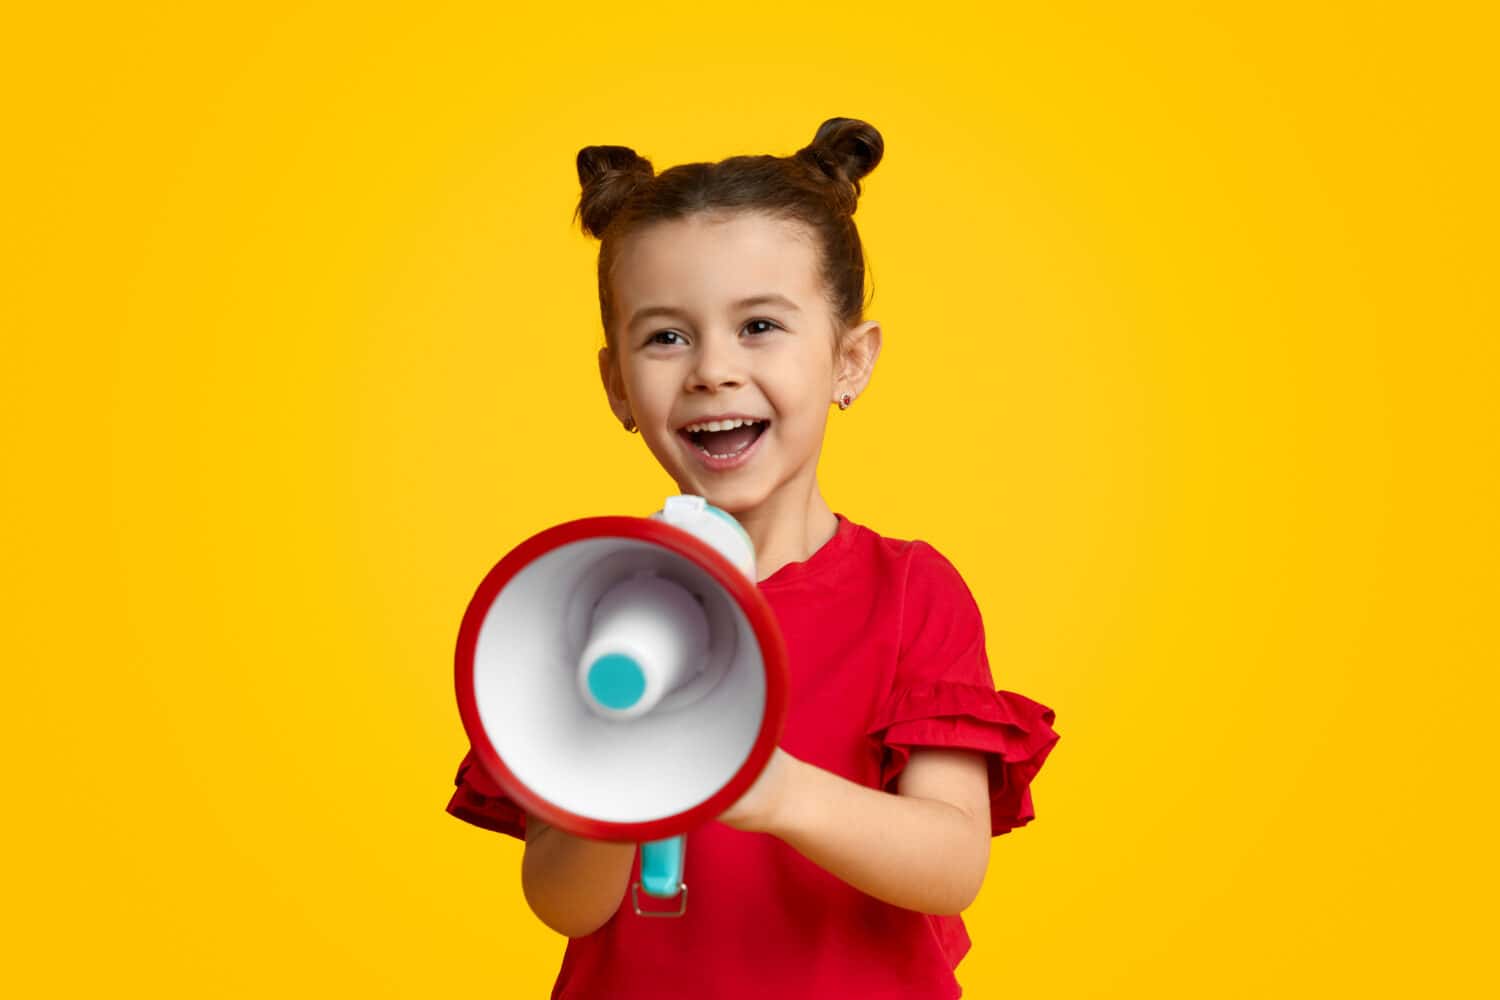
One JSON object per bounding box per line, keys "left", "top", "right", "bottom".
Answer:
{"left": 447, "top": 514, "right": 1058, "bottom": 1000}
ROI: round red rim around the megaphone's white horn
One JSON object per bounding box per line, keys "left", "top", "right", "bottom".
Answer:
{"left": 453, "top": 517, "right": 788, "bottom": 843}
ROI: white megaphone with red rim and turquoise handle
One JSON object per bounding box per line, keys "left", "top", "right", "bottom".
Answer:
{"left": 455, "top": 493, "right": 788, "bottom": 916}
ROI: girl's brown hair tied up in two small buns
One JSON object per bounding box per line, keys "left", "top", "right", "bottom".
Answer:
{"left": 573, "top": 118, "right": 885, "bottom": 352}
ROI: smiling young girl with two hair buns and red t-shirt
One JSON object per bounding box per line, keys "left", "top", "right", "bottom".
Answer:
{"left": 447, "top": 118, "right": 1058, "bottom": 1000}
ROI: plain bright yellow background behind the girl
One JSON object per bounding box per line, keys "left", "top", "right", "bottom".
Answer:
{"left": 0, "top": 1, "right": 1500, "bottom": 999}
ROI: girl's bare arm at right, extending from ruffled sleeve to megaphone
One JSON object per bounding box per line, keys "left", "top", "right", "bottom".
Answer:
{"left": 720, "top": 748, "right": 990, "bottom": 915}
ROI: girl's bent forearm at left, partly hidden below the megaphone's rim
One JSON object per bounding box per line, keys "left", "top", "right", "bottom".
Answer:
{"left": 521, "top": 813, "right": 638, "bottom": 937}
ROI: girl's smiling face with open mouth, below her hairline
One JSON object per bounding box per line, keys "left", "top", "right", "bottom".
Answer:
{"left": 600, "top": 213, "right": 875, "bottom": 513}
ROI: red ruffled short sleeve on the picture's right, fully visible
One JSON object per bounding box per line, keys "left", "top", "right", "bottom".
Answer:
{"left": 867, "top": 541, "right": 1059, "bottom": 837}
